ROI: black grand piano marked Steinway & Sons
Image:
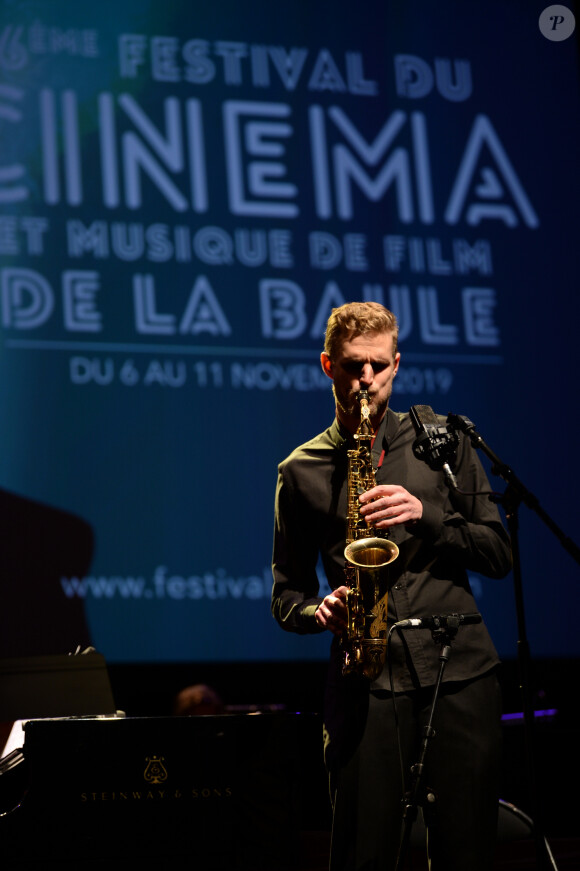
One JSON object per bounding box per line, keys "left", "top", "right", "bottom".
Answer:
{"left": 0, "top": 657, "right": 328, "bottom": 871}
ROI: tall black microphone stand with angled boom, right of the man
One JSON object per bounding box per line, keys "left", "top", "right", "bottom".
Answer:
{"left": 447, "top": 414, "right": 580, "bottom": 869}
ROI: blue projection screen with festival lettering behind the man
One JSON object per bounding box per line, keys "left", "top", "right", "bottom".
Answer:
{"left": 0, "top": 0, "right": 580, "bottom": 663}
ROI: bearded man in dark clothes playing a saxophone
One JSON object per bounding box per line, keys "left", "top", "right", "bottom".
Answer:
{"left": 272, "top": 302, "right": 511, "bottom": 871}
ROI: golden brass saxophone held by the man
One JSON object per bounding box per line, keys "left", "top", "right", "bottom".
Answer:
{"left": 342, "top": 390, "right": 399, "bottom": 681}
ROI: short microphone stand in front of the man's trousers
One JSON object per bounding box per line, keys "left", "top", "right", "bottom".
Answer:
{"left": 395, "top": 615, "right": 460, "bottom": 871}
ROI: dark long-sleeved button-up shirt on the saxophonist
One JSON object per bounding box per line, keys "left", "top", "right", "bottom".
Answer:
{"left": 272, "top": 409, "right": 511, "bottom": 690}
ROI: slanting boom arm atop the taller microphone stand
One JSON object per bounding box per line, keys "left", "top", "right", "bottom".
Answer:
{"left": 447, "top": 413, "right": 580, "bottom": 565}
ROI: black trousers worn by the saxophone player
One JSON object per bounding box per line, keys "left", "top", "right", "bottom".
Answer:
{"left": 325, "top": 673, "right": 501, "bottom": 871}
